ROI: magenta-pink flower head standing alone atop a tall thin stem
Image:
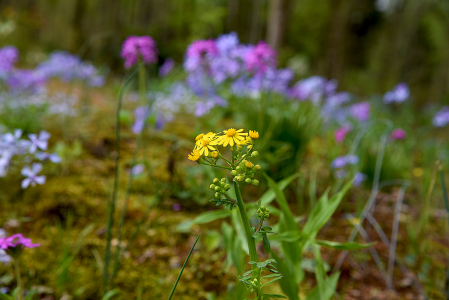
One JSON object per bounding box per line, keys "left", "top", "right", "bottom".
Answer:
{"left": 120, "top": 36, "right": 158, "bottom": 69}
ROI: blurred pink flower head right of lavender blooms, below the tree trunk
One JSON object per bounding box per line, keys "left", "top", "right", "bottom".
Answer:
{"left": 245, "top": 41, "right": 277, "bottom": 73}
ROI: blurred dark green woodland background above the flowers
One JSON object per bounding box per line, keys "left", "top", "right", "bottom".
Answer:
{"left": 0, "top": 0, "right": 449, "bottom": 106}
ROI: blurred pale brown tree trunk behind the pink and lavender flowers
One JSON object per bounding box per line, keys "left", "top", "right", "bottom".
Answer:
{"left": 267, "top": 0, "right": 291, "bottom": 50}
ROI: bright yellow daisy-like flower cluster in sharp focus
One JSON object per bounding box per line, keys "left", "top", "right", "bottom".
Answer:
{"left": 188, "top": 128, "right": 259, "bottom": 161}
